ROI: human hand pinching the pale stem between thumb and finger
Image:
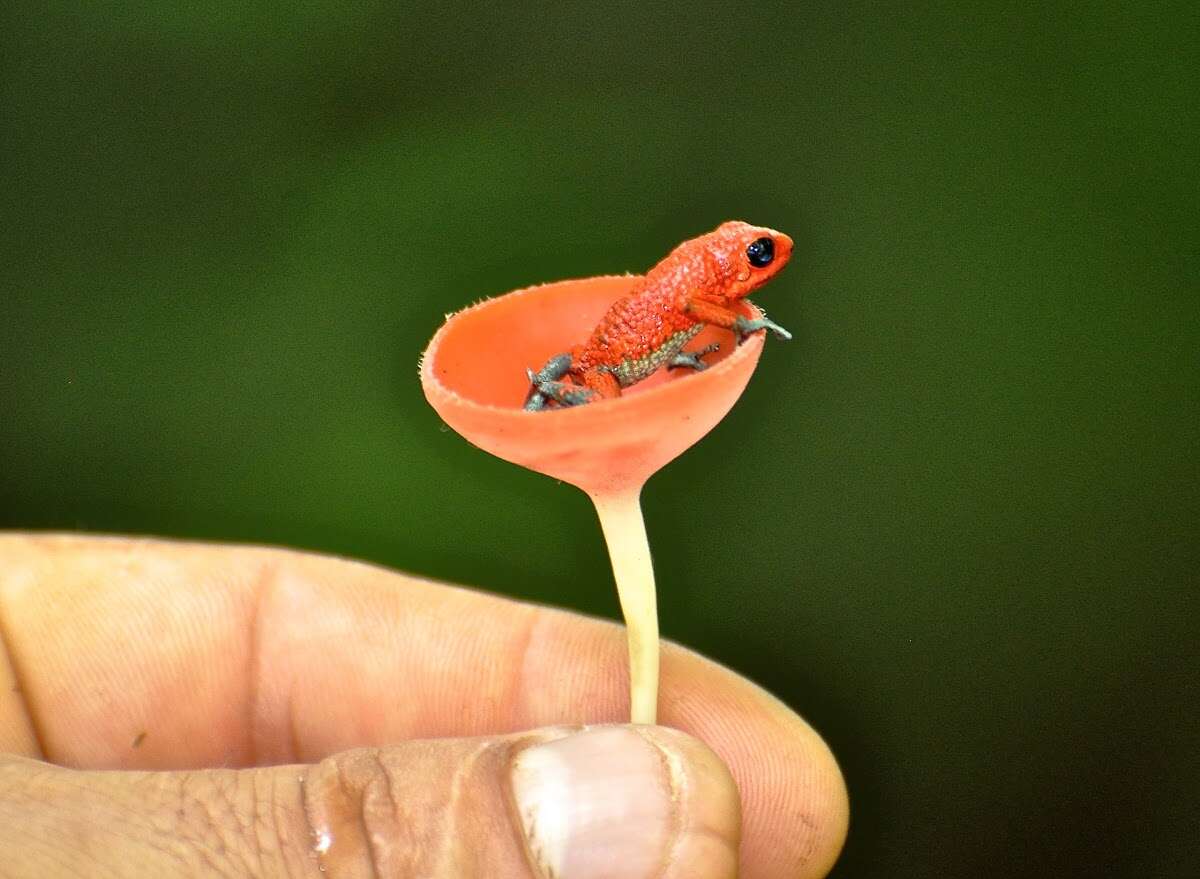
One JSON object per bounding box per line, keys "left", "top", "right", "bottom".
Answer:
{"left": 0, "top": 534, "right": 847, "bottom": 879}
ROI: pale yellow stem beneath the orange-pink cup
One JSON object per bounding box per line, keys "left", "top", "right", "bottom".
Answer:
{"left": 592, "top": 486, "right": 659, "bottom": 723}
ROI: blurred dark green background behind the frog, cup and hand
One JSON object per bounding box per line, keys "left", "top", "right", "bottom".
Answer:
{"left": 0, "top": 2, "right": 1200, "bottom": 878}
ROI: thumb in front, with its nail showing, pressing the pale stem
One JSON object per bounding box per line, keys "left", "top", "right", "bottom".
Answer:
{"left": 0, "top": 725, "right": 740, "bottom": 879}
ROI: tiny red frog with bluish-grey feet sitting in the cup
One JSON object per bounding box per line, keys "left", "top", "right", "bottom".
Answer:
{"left": 524, "top": 221, "right": 792, "bottom": 411}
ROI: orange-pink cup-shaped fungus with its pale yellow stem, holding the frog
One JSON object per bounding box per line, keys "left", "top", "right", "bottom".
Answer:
{"left": 421, "top": 275, "right": 763, "bottom": 723}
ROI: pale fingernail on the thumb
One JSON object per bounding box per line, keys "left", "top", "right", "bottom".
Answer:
{"left": 512, "top": 726, "right": 682, "bottom": 879}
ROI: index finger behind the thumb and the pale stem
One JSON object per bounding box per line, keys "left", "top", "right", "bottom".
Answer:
{"left": 0, "top": 537, "right": 846, "bottom": 877}
